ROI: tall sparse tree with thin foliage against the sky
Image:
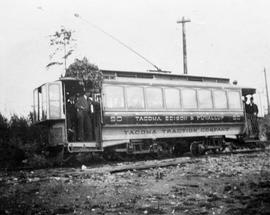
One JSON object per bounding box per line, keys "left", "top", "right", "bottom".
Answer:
{"left": 46, "top": 27, "right": 76, "bottom": 71}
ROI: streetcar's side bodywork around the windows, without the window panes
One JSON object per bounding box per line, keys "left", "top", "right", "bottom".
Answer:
{"left": 102, "top": 72, "right": 245, "bottom": 147}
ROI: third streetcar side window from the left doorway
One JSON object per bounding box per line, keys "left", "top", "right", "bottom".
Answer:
{"left": 145, "top": 87, "right": 163, "bottom": 109}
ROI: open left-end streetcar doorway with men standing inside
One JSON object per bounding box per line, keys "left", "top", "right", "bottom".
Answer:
{"left": 64, "top": 79, "right": 101, "bottom": 142}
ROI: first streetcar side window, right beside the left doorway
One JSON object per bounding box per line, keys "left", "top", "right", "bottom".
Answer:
{"left": 104, "top": 86, "right": 125, "bottom": 108}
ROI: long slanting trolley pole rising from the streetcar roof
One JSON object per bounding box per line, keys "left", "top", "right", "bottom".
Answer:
{"left": 74, "top": 13, "right": 162, "bottom": 71}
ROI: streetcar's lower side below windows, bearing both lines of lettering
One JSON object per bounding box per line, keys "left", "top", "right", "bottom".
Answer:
{"left": 102, "top": 112, "right": 244, "bottom": 141}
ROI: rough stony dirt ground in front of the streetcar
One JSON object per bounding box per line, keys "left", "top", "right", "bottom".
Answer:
{"left": 0, "top": 150, "right": 270, "bottom": 215}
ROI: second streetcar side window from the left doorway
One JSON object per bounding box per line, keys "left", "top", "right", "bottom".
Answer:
{"left": 126, "top": 87, "right": 144, "bottom": 109}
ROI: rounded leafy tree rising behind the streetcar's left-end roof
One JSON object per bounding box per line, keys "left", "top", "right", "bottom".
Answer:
{"left": 65, "top": 57, "right": 103, "bottom": 90}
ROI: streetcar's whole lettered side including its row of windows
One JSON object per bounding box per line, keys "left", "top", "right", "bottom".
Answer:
{"left": 102, "top": 80, "right": 244, "bottom": 147}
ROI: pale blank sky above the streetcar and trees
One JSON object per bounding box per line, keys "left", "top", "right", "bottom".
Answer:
{"left": 0, "top": 0, "right": 270, "bottom": 116}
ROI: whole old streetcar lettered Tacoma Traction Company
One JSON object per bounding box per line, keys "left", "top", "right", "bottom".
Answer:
{"left": 33, "top": 70, "right": 256, "bottom": 159}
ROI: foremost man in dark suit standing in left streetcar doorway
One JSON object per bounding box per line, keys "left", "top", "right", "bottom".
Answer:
{"left": 75, "top": 91, "right": 93, "bottom": 141}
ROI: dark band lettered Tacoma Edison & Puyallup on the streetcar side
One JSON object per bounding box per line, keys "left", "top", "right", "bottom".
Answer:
{"left": 104, "top": 114, "right": 244, "bottom": 125}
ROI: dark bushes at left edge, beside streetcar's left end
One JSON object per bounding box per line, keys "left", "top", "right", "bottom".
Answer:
{"left": 0, "top": 113, "right": 47, "bottom": 168}
